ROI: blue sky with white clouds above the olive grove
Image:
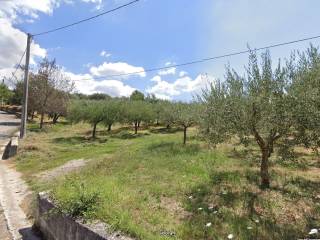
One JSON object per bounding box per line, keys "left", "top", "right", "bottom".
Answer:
{"left": 0, "top": 0, "right": 320, "bottom": 101}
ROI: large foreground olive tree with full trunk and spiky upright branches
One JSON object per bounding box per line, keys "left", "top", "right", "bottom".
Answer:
{"left": 202, "top": 51, "right": 293, "bottom": 188}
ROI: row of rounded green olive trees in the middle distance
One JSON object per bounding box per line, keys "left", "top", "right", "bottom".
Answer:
{"left": 68, "top": 96, "right": 199, "bottom": 144}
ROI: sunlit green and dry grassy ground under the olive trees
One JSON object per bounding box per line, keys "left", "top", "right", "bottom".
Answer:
{"left": 15, "top": 123, "right": 320, "bottom": 240}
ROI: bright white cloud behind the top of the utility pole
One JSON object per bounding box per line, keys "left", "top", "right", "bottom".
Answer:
{"left": 0, "top": 0, "right": 66, "bottom": 82}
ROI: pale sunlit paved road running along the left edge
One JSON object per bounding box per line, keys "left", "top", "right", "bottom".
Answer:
{"left": 0, "top": 112, "right": 39, "bottom": 240}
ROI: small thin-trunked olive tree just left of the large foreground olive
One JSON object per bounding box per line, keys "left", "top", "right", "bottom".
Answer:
{"left": 172, "top": 103, "right": 198, "bottom": 144}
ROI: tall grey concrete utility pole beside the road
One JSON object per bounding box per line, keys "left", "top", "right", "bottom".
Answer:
{"left": 20, "top": 33, "right": 32, "bottom": 138}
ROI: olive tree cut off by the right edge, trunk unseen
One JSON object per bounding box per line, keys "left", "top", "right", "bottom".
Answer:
{"left": 288, "top": 45, "right": 320, "bottom": 162}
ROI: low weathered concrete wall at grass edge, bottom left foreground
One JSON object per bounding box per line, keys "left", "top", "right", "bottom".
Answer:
{"left": 35, "top": 193, "right": 133, "bottom": 240}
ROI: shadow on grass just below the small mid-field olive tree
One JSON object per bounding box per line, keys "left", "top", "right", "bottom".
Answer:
{"left": 147, "top": 142, "right": 201, "bottom": 156}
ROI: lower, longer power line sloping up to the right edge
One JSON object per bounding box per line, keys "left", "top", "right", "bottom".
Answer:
{"left": 68, "top": 32, "right": 320, "bottom": 81}
